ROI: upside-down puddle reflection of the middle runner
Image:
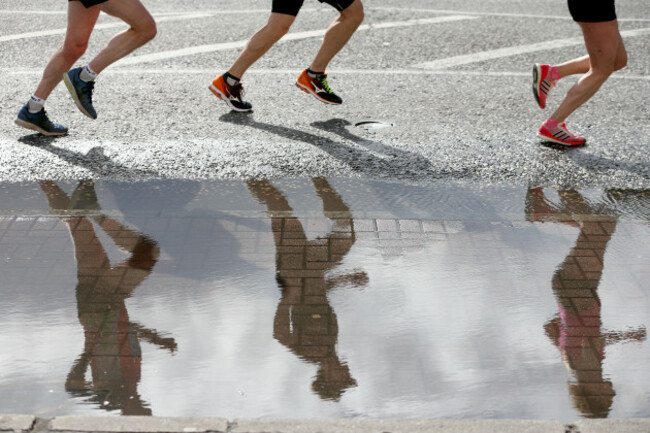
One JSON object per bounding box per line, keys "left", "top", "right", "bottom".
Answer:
{"left": 248, "top": 178, "right": 368, "bottom": 400}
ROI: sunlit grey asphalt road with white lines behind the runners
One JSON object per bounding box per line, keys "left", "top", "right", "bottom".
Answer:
{"left": 0, "top": 0, "right": 650, "bottom": 189}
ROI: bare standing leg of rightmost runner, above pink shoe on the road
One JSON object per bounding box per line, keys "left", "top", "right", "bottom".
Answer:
{"left": 551, "top": 20, "right": 627, "bottom": 122}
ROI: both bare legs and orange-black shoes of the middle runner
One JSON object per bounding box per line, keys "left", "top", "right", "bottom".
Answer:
{"left": 210, "top": 0, "right": 363, "bottom": 111}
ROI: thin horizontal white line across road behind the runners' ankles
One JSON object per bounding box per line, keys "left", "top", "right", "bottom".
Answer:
{"left": 5, "top": 65, "right": 650, "bottom": 81}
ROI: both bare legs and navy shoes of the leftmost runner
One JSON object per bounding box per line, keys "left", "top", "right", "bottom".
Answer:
{"left": 15, "top": 0, "right": 156, "bottom": 135}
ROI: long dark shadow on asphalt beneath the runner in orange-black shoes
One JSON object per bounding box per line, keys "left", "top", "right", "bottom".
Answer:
{"left": 219, "top": 111, "right": 467, "bottom": 179}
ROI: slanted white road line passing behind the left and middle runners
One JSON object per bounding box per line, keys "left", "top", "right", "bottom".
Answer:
{"left": 116, "top": 15, "right": 477, "bottom": 66}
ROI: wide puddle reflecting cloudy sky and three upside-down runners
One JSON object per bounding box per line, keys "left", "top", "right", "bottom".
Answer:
{"left": 0, "top": 178, "right": 650, "bottom": 421}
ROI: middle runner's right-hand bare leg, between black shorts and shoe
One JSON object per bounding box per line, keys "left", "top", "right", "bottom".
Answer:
{"left": 309, "top": 0, "right": 364, "bottom": 72}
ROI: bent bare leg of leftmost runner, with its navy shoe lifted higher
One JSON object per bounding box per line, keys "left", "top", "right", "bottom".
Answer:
{"left": 90, "top": 0, "right": 157, "bottom": 73}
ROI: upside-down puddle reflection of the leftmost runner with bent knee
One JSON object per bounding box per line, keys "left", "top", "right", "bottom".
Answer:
{"left": 39, "top": 181, "right": 176, "bottom": 415}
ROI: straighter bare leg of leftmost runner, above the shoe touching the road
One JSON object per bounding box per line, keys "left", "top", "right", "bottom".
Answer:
{"left": 34, "top": 1, "right": 100, "bottom": 99}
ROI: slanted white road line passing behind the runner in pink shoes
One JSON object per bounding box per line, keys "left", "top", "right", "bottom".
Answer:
{"left": 413, "top": 28, "right": 650, "bottom": 69}
